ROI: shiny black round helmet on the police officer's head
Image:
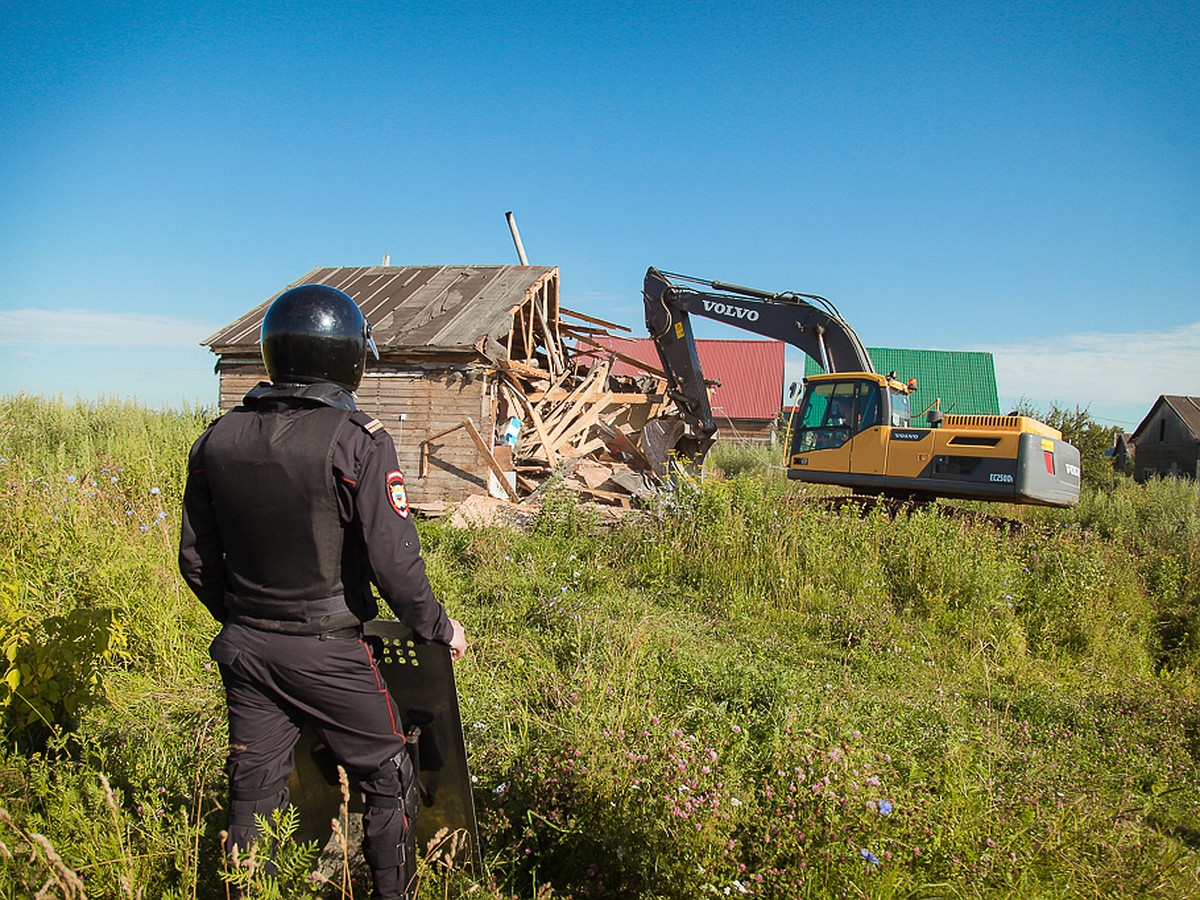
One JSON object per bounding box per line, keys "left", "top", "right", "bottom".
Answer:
{"left": 262, "top": 284, "right": 379, "bottom": 391}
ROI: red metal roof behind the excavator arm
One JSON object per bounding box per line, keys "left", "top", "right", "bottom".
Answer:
{"left": 582, "top": 337, "right": 784, "bottom": 425}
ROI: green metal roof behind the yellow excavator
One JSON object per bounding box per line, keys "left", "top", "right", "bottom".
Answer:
{"left": 804, "top": 347, "right": 1000, "bottom": 419}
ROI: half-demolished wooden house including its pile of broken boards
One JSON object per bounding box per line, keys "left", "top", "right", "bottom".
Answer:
{"left": 203, "top": 265, "right": 700, "bottom": 509}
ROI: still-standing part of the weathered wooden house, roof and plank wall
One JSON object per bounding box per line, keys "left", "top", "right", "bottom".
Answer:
{"left": 203, "top": 265, "right": 566, "bottom": 504}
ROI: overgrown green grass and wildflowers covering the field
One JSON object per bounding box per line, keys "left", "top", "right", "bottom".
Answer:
{"left": 0, "top": 397, "right": 1200, "bottom": 898}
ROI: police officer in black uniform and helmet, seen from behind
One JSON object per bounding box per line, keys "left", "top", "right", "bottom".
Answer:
{"left": 179, "top": 284, "right": 467, "bottom": 900}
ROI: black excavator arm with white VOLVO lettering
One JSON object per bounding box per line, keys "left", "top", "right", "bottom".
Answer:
{"left": 642, "top": 266, "right": 875, "bottom": 456}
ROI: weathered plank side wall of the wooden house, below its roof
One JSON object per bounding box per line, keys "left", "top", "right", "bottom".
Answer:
{"left": 220, "top": 361, "right": 496, "bottom": 504}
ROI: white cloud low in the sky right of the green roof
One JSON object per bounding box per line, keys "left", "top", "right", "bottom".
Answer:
{"left": 972, "top": 322, "right": 1200, "bottom": 409}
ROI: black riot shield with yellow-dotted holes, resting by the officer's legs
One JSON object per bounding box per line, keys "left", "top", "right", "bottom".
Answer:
{"left": 289, "top": 622, "right": 482, "bottom": 874}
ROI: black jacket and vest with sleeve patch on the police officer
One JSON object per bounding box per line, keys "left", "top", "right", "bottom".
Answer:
{"left": 179, "top": 383, "right": 454, "bottom": 643}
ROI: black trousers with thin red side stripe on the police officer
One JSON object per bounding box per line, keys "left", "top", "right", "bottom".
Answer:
{"left": 209, "top": 623, "right": 409, "bottom": 898}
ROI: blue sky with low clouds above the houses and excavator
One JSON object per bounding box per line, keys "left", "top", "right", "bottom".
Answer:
{"left": 0, "top": 0, "right": 1200, "bottom": 427}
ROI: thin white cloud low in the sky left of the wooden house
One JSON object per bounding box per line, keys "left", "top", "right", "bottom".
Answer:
{"left": 0, "top": 308, "right": 216, "bottom": 348}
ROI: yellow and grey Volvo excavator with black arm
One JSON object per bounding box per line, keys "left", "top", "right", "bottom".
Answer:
{"left": 642, "top": 266, "right": 1081, "bottom": 506}
